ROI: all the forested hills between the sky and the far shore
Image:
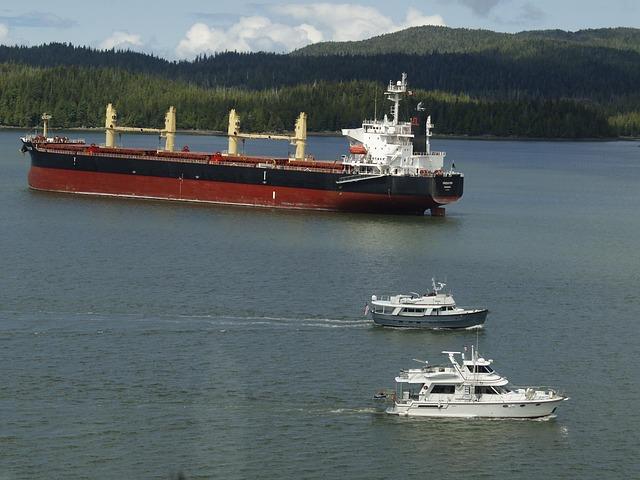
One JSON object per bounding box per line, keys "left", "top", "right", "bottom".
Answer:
{"left": 0, "top": 27, "right": 640, "bottom": 138}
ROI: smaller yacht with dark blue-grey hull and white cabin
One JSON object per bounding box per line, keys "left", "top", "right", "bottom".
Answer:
{"left": 369, "top": 279, "right": 488, "bottom": 328}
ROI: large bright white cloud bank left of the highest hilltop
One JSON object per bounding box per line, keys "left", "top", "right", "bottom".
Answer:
{"left": 176, "top": 3, "right": 444, "bottom": 58}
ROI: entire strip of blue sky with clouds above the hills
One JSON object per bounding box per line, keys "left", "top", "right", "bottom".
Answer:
{"left": 0, "top": 0, "right": 640, "bottom": 59}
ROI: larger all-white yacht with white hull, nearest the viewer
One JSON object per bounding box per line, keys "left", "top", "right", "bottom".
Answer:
{"left": 377, "top": 347, "right": 568, "bottom": 418}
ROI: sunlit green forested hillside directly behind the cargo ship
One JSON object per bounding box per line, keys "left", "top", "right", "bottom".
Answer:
{"left": 0, "top": 65, "right": 613, "bottom": 138}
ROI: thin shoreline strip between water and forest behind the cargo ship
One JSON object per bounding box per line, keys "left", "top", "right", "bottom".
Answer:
{"left": 0, "top": 125, "right": 640, "bottom": 142}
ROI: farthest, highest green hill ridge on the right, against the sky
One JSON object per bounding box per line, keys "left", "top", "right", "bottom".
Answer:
{"left": 291, "top": 25, "right": 640, "bottom": 55}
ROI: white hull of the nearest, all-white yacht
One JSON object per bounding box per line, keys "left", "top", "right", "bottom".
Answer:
{"left": 386, "top": 397, "right": 566, "bottom": 418}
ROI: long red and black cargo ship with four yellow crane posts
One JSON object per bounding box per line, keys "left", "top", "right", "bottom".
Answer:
{"left": 21, "top": 74, "right": 464, "bottom": 216}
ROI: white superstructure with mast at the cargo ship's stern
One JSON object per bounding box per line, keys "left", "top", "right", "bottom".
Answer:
{"left": 342, "top": 73, "right": 450, "bottom": 175}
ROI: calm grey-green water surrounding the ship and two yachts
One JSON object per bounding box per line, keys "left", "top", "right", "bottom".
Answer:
{"left": 0, "top": 131, "right": 640, "bottom": 479}
